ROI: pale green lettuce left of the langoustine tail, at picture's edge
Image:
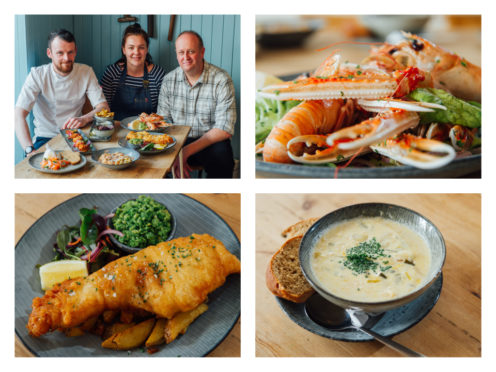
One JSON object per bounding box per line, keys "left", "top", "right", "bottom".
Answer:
{"left": 255, "top": 96, "right": 301, "bottom": 143}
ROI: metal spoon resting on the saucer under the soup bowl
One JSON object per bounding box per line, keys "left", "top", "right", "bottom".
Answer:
{"left": 305, "top": 293, "right": 425, "bottom": 357}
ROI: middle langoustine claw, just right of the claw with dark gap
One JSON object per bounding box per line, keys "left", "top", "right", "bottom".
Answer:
{"left": 327, "top": 109, "right": 420, "bottom": 151}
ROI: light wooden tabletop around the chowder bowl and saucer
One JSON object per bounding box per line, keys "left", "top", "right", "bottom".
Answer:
{"left": 256, "top": 194, "right": 481, "bottom": 357}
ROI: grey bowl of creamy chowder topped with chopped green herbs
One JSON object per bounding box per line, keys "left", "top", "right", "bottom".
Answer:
{"left": 299, "top": 203, "right": 446, "bottom": 313}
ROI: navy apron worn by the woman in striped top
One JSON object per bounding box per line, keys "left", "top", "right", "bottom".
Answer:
{"left": 112, "top": 66, "right": 153, "bottom": 120}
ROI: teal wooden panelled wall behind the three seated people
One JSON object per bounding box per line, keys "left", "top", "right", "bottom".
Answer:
{"left": 15, "top": 14, "right": 241, "bottom": 162}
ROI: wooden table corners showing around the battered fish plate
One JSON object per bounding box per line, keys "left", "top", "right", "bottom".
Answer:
{"left": 15, "top": 194, "right": 241, "bottom": 357}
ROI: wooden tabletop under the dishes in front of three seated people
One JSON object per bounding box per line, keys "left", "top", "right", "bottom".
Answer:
{"left": 15, "top": 125, "right": 191, "bottom": 179}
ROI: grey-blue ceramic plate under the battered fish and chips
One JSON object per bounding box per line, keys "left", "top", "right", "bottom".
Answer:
{"left": 15, "top": 194, "right": 241, "bottom": 358}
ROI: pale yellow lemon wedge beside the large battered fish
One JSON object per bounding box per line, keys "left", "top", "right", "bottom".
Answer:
{"left": 40, "top": 260, "right": 88, "bottom": 291}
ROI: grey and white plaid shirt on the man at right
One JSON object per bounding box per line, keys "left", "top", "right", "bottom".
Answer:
{"left": 157, "top": 61, "right": 236, "bottom": 138}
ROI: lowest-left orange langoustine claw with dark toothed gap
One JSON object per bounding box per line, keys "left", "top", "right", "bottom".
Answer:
{"left": 287, "top": 134, "right": 357, "bottom": 164}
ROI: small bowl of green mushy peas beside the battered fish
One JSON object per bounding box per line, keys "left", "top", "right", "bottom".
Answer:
{"left": 109, "top": 195, "right": 176, "bottom": 253}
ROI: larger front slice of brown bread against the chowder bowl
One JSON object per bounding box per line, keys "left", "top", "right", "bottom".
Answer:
{"left": 265, "top": 236, "right": 314, "bottom": 303}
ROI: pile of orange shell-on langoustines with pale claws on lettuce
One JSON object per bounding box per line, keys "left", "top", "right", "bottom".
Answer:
{"left": 260, "top": 34, "right": 480, "bottom": 169}
